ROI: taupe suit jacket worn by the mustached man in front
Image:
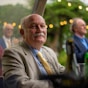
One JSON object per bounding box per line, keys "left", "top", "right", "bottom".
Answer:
{"left": 2, "top": 42, "right": 64, "bottom": 88}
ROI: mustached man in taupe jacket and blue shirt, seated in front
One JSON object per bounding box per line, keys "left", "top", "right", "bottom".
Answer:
{"left": 2, "top": 14, "right": 65, "bottom": 88}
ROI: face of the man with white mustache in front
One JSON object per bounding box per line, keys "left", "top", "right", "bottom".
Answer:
{"left": 24, "top": 15, "right": 47, "bottom": 47}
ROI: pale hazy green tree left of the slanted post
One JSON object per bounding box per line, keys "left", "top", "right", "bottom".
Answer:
{"left": 0, "top": 4, "right": 31, "bottom": 37}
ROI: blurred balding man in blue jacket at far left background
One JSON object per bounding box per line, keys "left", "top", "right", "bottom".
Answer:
{"left": 0, "top": 23, "right": 14, "bottom": 49}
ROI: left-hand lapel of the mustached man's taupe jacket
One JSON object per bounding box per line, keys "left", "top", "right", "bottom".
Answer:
{"left": 21, "top": 42, "right": 40, "bottom": 76}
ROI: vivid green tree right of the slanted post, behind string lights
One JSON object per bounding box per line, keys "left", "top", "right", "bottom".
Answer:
{"left": 44, "top": 0, "right": 88, "bottom": 52}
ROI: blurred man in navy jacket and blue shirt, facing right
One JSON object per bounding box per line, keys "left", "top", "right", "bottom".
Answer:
{"left": 70, "top": 18, "right": 88, "bottom": 63}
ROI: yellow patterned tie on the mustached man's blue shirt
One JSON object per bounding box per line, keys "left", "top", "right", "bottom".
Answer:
{"left": 37, "top": 52, "right": 53, "bottom": 75}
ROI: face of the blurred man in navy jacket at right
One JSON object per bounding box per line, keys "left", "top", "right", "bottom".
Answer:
{"left": 75, "top": 19, "right": 87, "bottom": 36}
